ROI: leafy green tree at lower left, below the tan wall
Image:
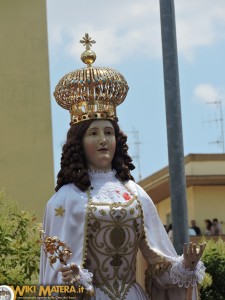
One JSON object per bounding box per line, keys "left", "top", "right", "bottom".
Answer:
{"left": 0, "top": 191, "right": 40, "bottom": 285}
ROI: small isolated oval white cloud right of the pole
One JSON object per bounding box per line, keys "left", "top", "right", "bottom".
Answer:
{"left": 194, "top": 84, "right": 223, "bottom": 103}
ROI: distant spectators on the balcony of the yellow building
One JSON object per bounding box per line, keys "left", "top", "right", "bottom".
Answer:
{"left": 164, "top": 218, "right": 223, "bottom": 240}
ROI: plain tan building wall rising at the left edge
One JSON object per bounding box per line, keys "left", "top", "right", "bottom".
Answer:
{"left": 0, "top": 0, "right": 54, "bottom": 220}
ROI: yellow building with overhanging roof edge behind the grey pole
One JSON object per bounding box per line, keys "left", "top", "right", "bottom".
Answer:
{"left": 140, "top": 154, "right": 225, "bottom": 234}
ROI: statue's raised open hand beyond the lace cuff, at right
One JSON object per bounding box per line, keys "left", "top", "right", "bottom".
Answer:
{"left": 183, "top": 243, "right": 206, "bottom": 270}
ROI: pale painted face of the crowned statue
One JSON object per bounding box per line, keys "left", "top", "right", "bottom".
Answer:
{"left": 82, "top": 120, "right": 116, "bottom": 171}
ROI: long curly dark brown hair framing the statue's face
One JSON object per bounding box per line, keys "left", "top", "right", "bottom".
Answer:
{"left": 55, "top": 120, "right": 135, "bottom": 191}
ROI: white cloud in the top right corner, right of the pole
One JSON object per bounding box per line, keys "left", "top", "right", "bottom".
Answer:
{"left": 176, "top": 0, "right": 225, "bottom": 60}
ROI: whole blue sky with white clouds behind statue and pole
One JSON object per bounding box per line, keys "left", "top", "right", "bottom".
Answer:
{"left": 47, "top": 0, "right": 225, "bottom": 180}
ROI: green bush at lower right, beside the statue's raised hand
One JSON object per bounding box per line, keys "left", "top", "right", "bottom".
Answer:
{"left": 200, "top": 238, "right": 225, "bottom": 300}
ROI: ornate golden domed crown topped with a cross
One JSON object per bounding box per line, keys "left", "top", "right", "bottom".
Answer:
{"left": 54, "top": 33, "right": 129, "bottom": 125}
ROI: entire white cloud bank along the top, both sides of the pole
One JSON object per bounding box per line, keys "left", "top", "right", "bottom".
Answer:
{"left": 47, "top": 0, "right": 225, "bottom": 64}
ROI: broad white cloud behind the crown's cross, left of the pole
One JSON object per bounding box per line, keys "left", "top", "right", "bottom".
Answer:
{"left": 47, "top": 0, "right": 161, "bottom": 65}
